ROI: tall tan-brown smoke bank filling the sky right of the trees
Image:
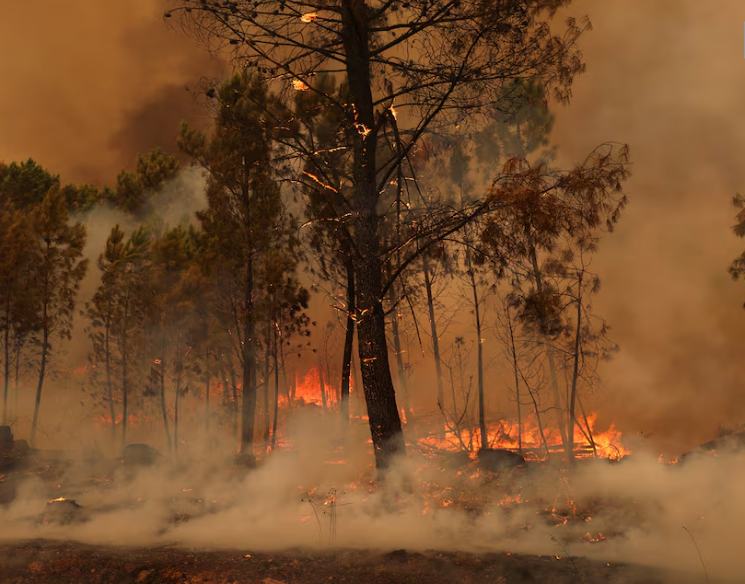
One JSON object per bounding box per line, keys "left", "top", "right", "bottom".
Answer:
{"left": 554, "top": 0, "right": 745, "bottom": 452}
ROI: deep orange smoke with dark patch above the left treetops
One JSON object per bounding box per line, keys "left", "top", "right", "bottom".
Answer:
{"left": 0, "top": 0, "right": 224, "bottom": 184}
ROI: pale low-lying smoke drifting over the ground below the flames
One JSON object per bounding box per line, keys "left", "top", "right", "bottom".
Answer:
{"left": 0, "top": 413, "right": 745, "bottom": 582}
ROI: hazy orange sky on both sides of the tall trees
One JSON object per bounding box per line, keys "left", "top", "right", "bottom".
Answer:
{"left": 0, "top": 0, "right": 745, "bottom": 450}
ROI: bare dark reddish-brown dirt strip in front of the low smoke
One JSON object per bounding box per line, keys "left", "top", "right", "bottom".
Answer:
{"left": 0, "top": 541, "right": 682, "bottom": 584}
